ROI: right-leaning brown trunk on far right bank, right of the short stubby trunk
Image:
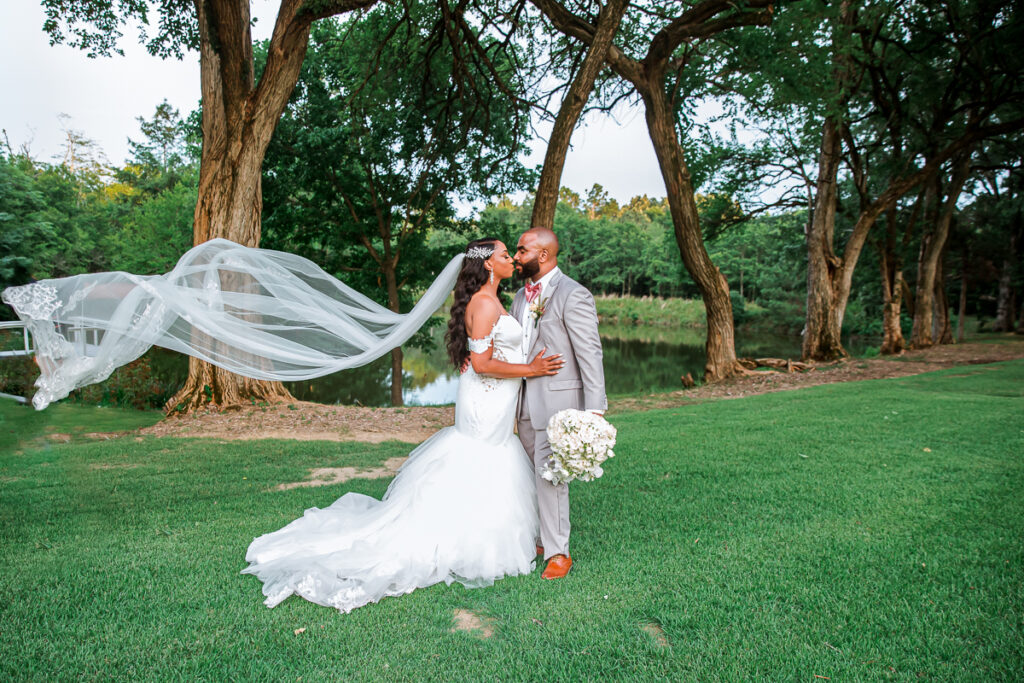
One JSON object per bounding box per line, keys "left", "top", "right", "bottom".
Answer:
{"left": 910, "top": 153, "right": 971, "bottom": 348}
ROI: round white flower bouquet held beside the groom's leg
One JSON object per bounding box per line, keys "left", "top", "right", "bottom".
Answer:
{"left": 541, "top": 409, "right": 615, "bottom": 484}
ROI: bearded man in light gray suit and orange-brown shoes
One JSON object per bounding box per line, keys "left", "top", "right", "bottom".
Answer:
{"left": 512, "top": 227, "right": 608, "bottom": 579}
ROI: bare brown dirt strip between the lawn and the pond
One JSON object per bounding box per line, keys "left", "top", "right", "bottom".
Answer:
{"left": 110, "top": 335, "right": 1024, "bottom": 443}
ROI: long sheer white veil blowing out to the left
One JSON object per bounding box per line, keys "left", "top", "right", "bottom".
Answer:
{"left": 2, "top": 240, "right": 464, "bottom": 410}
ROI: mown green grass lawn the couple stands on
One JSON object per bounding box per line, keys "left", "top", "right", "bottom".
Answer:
{"left": 0, "top": 361, "right": 1024, "bottom": 681}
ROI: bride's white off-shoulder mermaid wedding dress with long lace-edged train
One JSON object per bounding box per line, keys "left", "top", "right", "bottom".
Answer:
{"left": 243, "top": 315, "right": 538, "bottom": 612}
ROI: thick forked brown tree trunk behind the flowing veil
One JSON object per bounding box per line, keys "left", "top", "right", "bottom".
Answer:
{"left": 165, "top": 0, "right": 321, "bottom": 413}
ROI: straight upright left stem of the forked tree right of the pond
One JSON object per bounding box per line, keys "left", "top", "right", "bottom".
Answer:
{"left": 801, "top": 117, "right": 847, "bottom": 360}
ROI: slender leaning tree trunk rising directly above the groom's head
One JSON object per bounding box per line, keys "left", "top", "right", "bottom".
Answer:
{"left": 530, "top": 0, "right": 628, "bottom": 228}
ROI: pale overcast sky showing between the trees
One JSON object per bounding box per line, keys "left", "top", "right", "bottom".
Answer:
{"left": 0, "top": 0, "right": 665, "bottom": 209}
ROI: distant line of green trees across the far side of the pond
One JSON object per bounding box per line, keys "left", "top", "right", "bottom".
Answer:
{"left": 0, "top": 110, "right": 1024, "bottom": 350}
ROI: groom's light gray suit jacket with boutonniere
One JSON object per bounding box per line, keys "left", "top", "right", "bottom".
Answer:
{"left": 512, "top": 273, "right": 608, "bottom": 423}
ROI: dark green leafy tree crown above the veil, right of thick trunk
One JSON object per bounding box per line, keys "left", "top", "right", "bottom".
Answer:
{"left": 256, "top": 2, "right": 534, "bottom": 305}
